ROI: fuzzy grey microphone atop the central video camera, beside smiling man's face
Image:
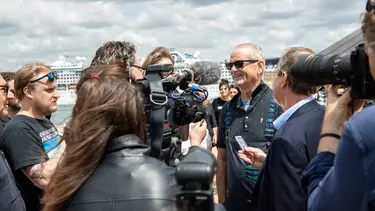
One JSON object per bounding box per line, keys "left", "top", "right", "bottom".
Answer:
{"left": 174, "top": 61, "right": 222, "bottom": 85}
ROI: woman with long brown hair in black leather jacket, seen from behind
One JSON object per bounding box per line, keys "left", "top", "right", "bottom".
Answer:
{"left": 43, "top": 64, "right": 200, "bottom": 211}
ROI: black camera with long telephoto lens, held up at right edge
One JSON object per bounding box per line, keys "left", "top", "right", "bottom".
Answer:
{"left": 290, "top": 44, "right": 375, "bottom": 99}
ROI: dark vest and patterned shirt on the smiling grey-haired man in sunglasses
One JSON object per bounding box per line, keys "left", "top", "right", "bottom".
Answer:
{"left": 217, "top": 83, "right": 282, "bottom": 204}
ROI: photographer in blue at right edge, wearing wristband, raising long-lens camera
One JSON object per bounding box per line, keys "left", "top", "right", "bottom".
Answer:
{"left": 302, "top": 1, "right": 375, "bottom": 211}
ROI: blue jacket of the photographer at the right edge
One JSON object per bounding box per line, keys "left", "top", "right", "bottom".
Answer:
{"left": 303, "top": 106, "right": 375, "bottom": 211}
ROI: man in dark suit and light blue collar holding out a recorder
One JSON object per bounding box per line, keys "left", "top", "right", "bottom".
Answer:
{"left": 239, "top": 47, "right": 324, "bottom": 211}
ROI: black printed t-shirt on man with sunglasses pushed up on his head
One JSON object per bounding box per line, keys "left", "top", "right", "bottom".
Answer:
{"left": 0, "top": 115, "right": 59, "bottom": 211}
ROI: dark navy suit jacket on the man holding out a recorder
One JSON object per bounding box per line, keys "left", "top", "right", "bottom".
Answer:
{"left": 249, "top": 100, "right": 325, "bottom": 211}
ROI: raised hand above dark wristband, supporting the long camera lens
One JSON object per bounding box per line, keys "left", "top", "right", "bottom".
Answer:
{"left": 322, "top": 85, "right": 364, "bottom": 134}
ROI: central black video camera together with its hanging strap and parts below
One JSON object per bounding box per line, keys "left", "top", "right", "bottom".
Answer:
{"left": 138, "top": 64, "right": 208, "bottom": 166}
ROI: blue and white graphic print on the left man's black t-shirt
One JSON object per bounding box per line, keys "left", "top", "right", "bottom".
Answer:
{"left": 39, "top": 127, "right": 60, "bottom": 158}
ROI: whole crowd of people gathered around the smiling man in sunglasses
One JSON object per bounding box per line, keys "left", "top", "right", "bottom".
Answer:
{"left": 0, "top": 2, "right": 375, "bottom": 211}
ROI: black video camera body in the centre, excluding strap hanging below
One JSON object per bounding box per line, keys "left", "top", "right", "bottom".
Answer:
{"left": 138, "top": 64, "right": 208, "bottom": 128}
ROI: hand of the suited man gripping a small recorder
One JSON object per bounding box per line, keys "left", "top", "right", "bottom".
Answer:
{"left": 238, "top": 147, "right": 267, "bottom": 169}
